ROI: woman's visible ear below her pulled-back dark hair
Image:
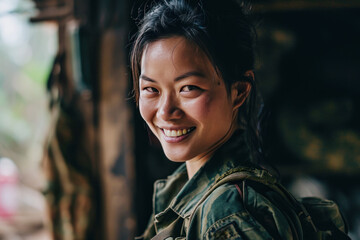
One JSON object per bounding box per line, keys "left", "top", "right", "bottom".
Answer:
{"left": 231, "top": 70, "right": 255, "bottom": 110}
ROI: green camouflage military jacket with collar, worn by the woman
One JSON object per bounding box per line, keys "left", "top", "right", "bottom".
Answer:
{"left": 138, "top": 132, "right": 348, "bottom": 240}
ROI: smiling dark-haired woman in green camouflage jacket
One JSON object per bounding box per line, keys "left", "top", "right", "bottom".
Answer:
{"left": 131, "top": 0, "right": 348, "bottom": 240}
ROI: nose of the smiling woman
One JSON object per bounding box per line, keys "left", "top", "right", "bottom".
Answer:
{"left": 157, "top": 95, "right": 184, "bottom": 121}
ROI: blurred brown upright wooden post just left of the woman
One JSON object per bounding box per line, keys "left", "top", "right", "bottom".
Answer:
{"left": 99, "top": 27, "right": 136, "bottom": 240}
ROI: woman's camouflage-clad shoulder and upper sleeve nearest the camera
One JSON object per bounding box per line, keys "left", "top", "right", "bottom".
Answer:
{"left": 189, "top": 183, "right": 278, "bottom": 239}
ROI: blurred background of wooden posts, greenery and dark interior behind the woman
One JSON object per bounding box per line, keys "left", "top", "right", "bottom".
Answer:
{"left": 0, "top": 0, "right": 360, "bottom": 240}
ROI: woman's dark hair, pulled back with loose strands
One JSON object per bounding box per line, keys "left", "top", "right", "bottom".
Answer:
{"left": 131, "top": 0, "right": 261, "bottom": 164}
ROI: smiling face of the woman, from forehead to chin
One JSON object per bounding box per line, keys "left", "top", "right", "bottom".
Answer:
{"left": 139, "top": 37, "right": 234, "bottom": 162}
